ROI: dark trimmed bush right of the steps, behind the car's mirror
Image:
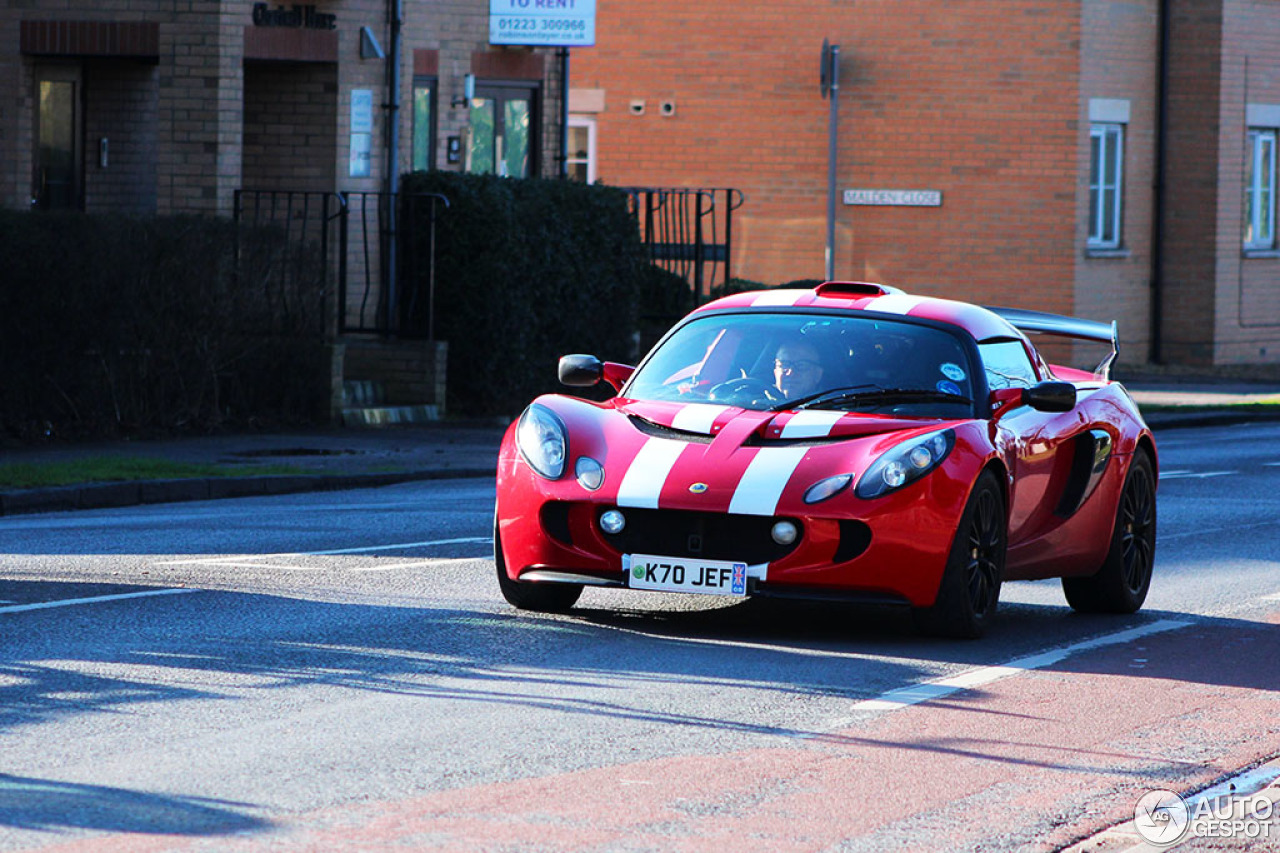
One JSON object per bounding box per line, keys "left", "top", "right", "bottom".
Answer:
{"left": 402, "top": 172, "right": 654, "bottom": 415}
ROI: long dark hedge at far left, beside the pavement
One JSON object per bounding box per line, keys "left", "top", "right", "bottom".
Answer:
{"left": 0, "top": 211, "right": 329, "bottom": 439}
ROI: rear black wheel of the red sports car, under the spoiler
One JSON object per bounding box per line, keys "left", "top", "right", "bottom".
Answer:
{"left": 1062, "top": 450, "right": 1156, "bottom": 613}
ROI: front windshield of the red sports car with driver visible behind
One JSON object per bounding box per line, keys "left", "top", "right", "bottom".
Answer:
{"left": 626, "top": 313, "right": 975, "bottom": 418}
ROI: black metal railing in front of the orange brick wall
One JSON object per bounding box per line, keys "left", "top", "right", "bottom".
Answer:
{"left": 627, "top": 187, "right": 745, "bottom": 305}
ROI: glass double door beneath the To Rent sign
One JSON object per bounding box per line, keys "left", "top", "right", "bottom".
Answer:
{"left": 467, "top": 83, "right": 538, "bottom": 178}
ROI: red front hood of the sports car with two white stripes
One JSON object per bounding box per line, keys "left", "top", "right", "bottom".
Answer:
{"left": 539, "top": 394, "right": 955, "bottom": 515}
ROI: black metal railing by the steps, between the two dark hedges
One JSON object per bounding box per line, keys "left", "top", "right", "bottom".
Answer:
{"left": 233, "top": 190, "right": 449, "bottom": 339}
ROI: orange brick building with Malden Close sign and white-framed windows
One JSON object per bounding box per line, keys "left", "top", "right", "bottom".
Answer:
{"left": 570, "top": 0, "right": 1280, "bottom": 365}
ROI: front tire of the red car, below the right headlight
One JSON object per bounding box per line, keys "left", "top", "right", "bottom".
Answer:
{"left": 911, "top": 471, "right": 1009, "bottom": 639}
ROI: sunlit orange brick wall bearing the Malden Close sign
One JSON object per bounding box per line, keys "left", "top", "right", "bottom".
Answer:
{"left": 572, "top": 0, "right": 1080, "bottom": 310}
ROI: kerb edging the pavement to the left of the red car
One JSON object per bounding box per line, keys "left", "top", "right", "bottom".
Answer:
{"left": 0, "top": 467, "right": 497, "bottom": 516}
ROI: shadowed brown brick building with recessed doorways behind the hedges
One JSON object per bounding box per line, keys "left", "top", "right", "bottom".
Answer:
{"left": 0, "top": 0, "right": 561, "bottom": 214}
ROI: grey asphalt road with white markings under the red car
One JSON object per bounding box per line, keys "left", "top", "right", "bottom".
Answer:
{"left": 0, "top": 424, "right": 1280, "bottom": 850}
